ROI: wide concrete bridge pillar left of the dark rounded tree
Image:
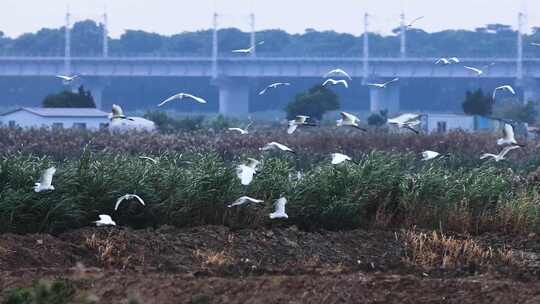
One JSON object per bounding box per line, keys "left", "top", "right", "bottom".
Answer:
{"left": 215, "top": 78, "right": 249, "bottom": 116}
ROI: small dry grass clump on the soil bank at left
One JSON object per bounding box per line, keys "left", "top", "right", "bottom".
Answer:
{"left": 84, "top": 233, "right": 131, "bottom": 268}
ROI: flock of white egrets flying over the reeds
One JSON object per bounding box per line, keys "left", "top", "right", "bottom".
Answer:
{"left": 47, "top": 22, "right": 540, "bottom": 226}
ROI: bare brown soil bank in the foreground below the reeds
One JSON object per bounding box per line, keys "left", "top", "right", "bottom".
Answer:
{"left": 0, "top": 226, "right": 540, "bottom": 304}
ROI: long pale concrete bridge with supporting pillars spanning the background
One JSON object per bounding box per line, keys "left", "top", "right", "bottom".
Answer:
{"left": 0, "top": 57, "right": 540, "bottom": 115}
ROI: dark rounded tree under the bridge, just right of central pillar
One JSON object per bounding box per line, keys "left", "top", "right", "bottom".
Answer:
{"left": 285, "top": 85, "right": 339, "bottom": 120}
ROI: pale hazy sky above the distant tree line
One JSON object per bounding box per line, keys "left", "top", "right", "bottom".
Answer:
{"left": 0, "top": 0, "right": 540, "bottom": 37}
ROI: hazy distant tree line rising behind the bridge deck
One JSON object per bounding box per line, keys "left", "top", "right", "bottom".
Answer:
{"left": 0, "top": 20, "right": 540, "bottom": 57}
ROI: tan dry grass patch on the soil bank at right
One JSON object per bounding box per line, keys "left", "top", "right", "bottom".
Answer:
{"left": 401, "top": 230, "right": 515, "bottom": 269}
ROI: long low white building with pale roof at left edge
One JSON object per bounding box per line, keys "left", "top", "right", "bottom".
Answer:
{"left": 0, "top": 108, "right": 109, "bottom": 130}
